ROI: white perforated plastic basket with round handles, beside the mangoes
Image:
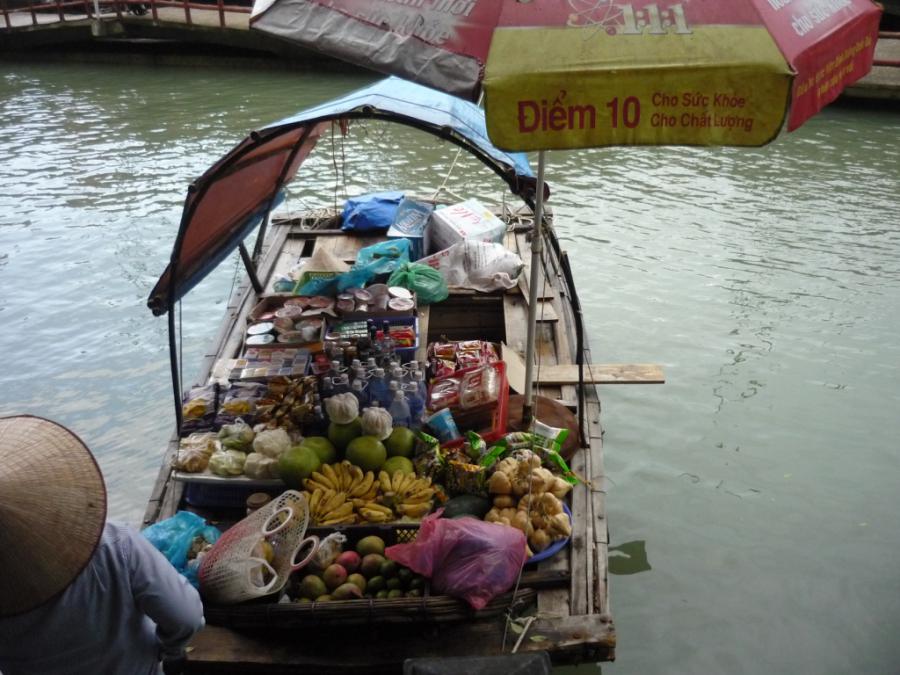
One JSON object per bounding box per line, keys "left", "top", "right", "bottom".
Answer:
{"left": 198, "top": 490, "right": 319, "bottom": 604}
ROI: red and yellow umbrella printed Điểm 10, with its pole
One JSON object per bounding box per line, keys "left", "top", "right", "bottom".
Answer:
{"left": 251, "top": 0, "right": 881, "bottom": 418}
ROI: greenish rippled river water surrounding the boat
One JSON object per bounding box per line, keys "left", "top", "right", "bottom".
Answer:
{"left": 0, "top": 64, "right": 900, "bottom": 675}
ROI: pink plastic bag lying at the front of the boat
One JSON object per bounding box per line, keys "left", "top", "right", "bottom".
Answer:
{"left": 384, "top": 509, "right": 525, "bottom": 609}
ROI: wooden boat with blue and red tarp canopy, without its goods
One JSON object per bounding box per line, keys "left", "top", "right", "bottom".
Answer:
{"left": 144, "top": 79, "right": 662, "bottom": 674}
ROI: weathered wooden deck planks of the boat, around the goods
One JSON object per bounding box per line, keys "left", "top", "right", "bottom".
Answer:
{"left": 144, "top": 205, "right": 662, "bottom": 675}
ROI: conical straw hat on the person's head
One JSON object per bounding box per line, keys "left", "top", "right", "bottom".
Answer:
{"left": 0, "top": 415, "right": 106, "bottom": 616}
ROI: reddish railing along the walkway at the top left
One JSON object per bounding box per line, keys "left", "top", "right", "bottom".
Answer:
{"left": 0, "top": 0, "right": 251, "bottom": 30}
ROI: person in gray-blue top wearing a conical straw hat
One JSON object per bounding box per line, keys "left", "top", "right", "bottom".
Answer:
{"left": 0, "top": 415, "right": 204, "bottom": 675}
